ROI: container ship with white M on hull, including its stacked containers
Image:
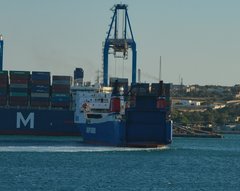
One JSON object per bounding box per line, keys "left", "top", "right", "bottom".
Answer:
{"left": 0, "top": 68, "right": 80, "bottom": 136}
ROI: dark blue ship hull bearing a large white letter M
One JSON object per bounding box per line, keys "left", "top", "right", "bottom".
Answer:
{"left": 0, "top": 108, "right": 80, "bottom": 136}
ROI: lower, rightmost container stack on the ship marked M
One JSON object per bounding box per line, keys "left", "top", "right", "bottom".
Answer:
{"left": 51, "top": 76, "right": 72, "bottom": 109}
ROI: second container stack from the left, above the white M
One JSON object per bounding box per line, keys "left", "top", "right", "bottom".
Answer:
{"left": 9, "top": 71, "right": 30, "bottom": 106}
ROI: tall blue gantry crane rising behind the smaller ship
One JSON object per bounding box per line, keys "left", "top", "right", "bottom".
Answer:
{"left": 103, "top": 4, "right": 137, "bottom": 86}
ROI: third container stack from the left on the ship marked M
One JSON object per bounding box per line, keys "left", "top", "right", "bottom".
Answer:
{"left": 31, "top": 72, "right": 50, "bottom": 107}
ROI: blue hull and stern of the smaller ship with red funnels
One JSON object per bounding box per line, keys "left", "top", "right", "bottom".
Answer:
{"left": 79, "top": 109, "right": 172, "bottom": 147}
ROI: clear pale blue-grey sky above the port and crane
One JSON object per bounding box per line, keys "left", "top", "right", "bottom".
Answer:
{"left": 0, "top": 0, "right": 240, "bottom": 85}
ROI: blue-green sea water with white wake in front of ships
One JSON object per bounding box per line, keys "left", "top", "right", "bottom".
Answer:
{"left": 0, "top": 135, "right": 240, "bottom": 191}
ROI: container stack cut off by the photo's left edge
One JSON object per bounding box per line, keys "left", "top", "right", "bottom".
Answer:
{"left": 0, "top": 71, "right": 8, "bottom": 106}
